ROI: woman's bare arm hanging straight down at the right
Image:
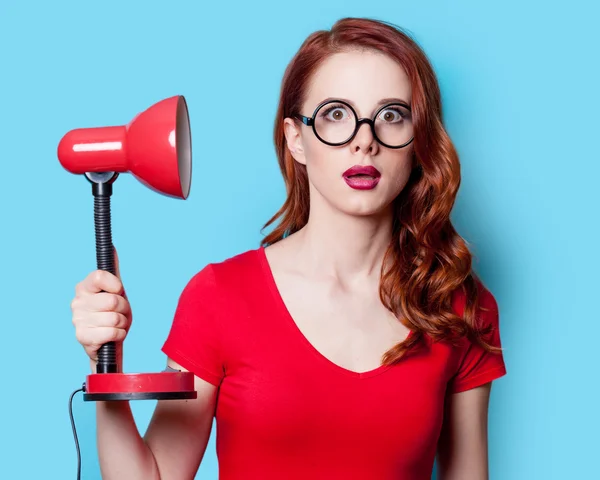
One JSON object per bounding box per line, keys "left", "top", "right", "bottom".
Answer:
{"left": 437, "top": 382, "right": 492, "bottom": 480}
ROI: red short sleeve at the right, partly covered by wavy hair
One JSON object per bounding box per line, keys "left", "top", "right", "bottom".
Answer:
{"left": 449, "top": 287, "right": 506, "bottom": 393}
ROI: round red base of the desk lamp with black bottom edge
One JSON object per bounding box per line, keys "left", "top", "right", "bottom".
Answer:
{"left": 83, "top": 372, "right": 198, "bottom": 402}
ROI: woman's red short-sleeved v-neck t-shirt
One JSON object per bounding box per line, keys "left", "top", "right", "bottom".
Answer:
{"left": 162, "top": 247, "right": 506, "bottom": 480}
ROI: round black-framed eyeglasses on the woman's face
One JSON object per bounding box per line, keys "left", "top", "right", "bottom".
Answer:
{"left": 294, "top": 100, "right": 414, "bottom": 148}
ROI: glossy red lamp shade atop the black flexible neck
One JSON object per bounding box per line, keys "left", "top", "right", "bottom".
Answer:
{"left": 58, "top": 95, "right": 192, "bottom": 199}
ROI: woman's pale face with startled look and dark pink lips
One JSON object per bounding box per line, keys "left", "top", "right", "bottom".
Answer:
{"left": 285, "top": 51, "right": 412, "bottom": 216}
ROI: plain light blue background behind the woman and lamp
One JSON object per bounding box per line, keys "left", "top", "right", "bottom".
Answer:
{"left": 0, "top": 0, "right": 600, "bottom": 480}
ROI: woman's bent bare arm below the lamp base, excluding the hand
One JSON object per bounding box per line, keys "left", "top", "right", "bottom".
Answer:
{"left": 96, "top": 359, "right": 217, "bottom": 480}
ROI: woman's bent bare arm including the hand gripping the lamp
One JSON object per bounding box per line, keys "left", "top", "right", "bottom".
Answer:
{"left": 71, "top": 253, "right": 217, "bottom": 480}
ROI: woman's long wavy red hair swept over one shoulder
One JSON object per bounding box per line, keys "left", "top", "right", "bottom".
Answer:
{"left": 261, "top": 18, "right": 501, "bottom": 364}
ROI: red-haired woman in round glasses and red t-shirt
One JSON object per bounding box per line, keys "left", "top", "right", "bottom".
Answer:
{"left": 72, "top": 15, "right": 506, "bottom": 480}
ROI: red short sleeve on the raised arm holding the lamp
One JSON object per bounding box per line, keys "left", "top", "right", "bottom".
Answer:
{"left": 161, "top": 264, "right": 224, "bottom": 386}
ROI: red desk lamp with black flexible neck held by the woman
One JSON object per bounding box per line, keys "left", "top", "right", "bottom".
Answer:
{"left": 58, "top": 96, "right": 197, "bottom": 401}
